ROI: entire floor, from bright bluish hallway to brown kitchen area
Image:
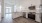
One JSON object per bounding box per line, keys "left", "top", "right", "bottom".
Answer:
{"left": 1, "top": 15, "right": 37, "bottom": 23}
